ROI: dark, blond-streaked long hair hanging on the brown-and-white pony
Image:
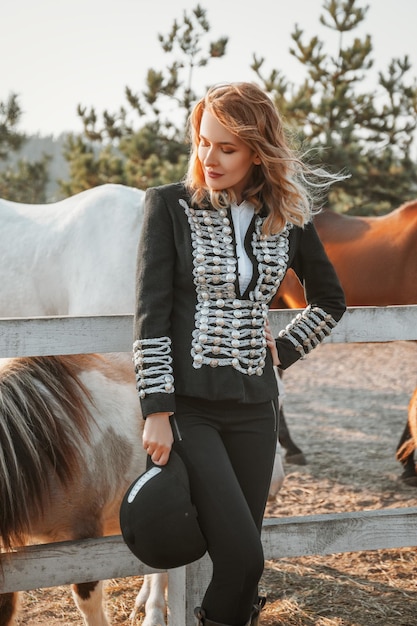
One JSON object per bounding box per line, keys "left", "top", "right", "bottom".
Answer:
{"left": 0, "top": 356, "right": 92, "bottom": 550}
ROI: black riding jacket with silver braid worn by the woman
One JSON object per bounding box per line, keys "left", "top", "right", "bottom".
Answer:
{"left": 134, "top": 183, "right": 346, "bottom": 417}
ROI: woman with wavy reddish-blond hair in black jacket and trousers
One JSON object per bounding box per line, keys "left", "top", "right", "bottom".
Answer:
{"left": 134, "top": 83, "right": 345, "bottom": 626}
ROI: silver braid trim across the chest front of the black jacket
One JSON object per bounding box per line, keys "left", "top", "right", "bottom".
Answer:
{"left": 180, "top": 200, "right": 291, "bottom": 376}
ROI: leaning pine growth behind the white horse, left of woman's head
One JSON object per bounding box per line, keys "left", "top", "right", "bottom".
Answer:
{"left": 61, "top": 5, "right": 227, "bottom": 194}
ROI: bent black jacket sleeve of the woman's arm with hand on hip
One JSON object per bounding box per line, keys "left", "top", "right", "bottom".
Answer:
{"left": 276, "top": 222, "right": 346, "bottom": 369}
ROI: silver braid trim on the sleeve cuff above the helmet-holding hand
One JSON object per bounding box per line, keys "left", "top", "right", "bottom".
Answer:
{"left": 133, "top": 337, "right": 175, "bottom": 398}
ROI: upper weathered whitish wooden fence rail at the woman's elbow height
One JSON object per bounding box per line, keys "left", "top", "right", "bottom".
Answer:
{"left": 0, "top": 305, "right": 417, "bottom": 357}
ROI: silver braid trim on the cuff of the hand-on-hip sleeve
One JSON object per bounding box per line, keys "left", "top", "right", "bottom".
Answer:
{"left": 279, "top": 305, "right": 336, "bottom": 357}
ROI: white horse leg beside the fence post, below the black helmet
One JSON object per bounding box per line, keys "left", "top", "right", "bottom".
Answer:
{"left": 130, "top": 572, "right": 168, "bottom": 626}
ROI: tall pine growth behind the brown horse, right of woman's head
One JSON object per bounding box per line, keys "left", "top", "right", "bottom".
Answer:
{"left": 252, "top": 0, "right": 417, "bottom": 214}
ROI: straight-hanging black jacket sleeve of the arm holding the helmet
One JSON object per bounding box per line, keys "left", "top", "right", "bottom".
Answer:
{"left": 133, "top": 188, "right": 175, "bottom": 418}
